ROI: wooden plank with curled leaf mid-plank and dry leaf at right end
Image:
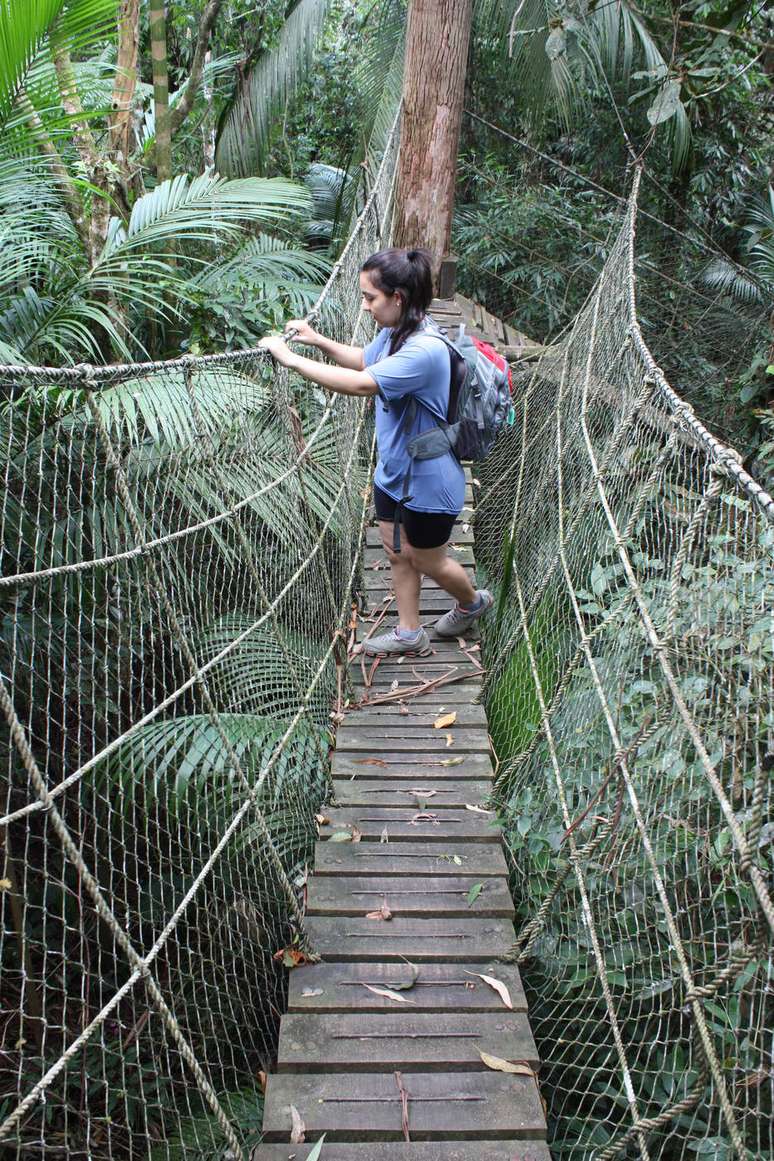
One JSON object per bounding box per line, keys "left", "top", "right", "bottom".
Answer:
{"left": 288, "top": 962, "right": 527, "bottom": 1012}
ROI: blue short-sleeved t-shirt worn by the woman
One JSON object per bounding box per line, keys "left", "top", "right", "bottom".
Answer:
{"left": 363, "top": 326, "right": 465, "bottom": 515}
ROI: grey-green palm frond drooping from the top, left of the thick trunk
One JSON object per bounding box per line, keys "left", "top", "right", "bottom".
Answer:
{"left": 215, "top": 0, "right": 331, "bottom": 175}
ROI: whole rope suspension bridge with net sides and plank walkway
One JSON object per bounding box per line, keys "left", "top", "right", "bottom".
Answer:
{"left": 0, "top": 110, "right": 774, "bottom": 1161}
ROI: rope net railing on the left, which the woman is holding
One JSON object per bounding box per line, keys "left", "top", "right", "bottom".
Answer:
{"left": 0, "top": 124, "right": 398, "bottom": 1161}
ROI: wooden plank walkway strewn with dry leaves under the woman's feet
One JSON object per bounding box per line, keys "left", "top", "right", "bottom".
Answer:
{"left": 253, "top": 303, "right": 550, "bottom": 1161}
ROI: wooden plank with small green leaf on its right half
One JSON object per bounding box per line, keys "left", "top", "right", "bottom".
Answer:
{"left": 306, "top": 873, "right": 515, "bottom": 923}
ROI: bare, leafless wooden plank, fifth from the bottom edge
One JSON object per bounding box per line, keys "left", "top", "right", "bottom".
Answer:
{"left": 306, "top": 915, "right": 514, "bottom": 964}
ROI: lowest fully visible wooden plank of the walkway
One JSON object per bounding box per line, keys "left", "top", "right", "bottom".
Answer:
{"left": 263, "top": 1072, "right": 545, "bottom": 1144}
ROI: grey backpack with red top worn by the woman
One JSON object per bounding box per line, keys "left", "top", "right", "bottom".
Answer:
{"left": 393, "top": 317, "right": 514, "bottom": 553}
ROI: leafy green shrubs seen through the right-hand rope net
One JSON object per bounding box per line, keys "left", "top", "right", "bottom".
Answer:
{"left": 487, "top": 501, "right": 774, "bottom": 1161}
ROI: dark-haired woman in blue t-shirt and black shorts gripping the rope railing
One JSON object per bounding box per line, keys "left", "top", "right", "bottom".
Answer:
{"left": 260, "top": 250, "right": 492, "bottom": 657}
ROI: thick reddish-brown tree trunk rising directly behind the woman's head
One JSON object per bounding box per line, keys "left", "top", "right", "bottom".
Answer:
{"left": 396, "top": 0, "right": 472, "bottom": 275}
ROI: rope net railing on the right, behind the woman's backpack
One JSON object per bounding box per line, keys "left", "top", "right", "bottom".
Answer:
{"left": 475, "top": 169, "right": 774, "bottom": 1161}
